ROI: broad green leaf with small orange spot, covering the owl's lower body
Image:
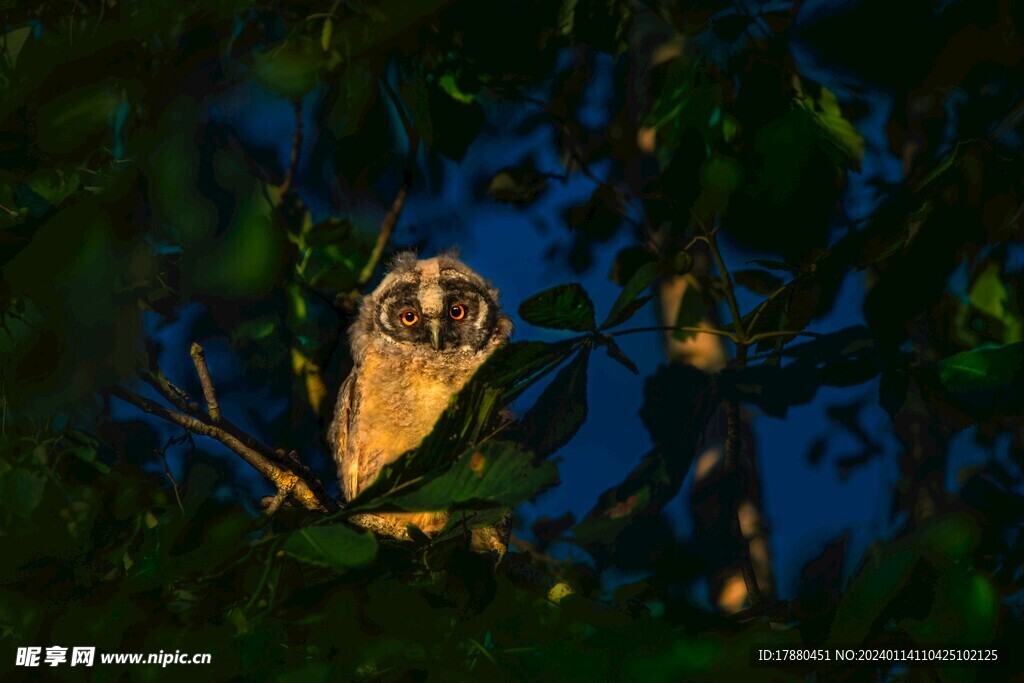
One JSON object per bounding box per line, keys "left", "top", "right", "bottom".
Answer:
{"left": 390, "top": 441, "right": 558, "bottom": 511}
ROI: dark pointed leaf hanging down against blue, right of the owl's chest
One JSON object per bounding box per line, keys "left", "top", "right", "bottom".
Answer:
{"left": 522, "top": 347, "right": 590, "bottom": 458}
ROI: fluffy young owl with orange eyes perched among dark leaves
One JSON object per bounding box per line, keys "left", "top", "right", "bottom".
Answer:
{"left": 328, "top": 253, "right": 512, "bottom": 533}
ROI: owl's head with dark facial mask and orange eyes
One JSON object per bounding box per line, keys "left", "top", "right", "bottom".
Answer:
{"left": 350, "top": 252, "right": 512, "bottom": 358}
